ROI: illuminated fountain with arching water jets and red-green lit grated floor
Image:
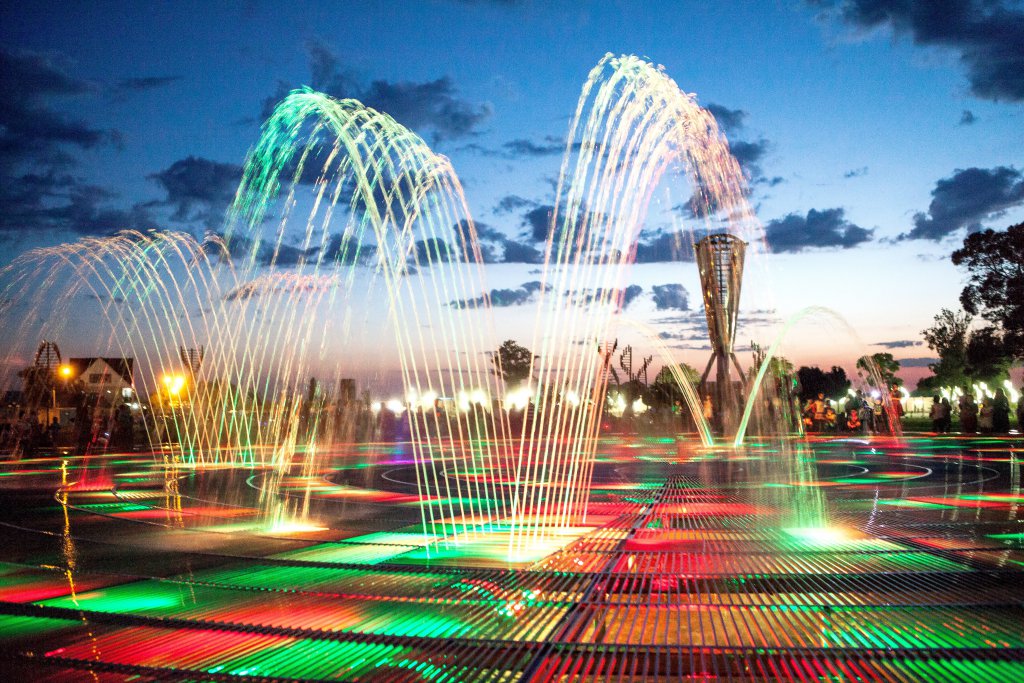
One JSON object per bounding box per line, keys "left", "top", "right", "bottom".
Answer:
{"left": 0, "top": 56, "right": 1024, "bottom": 681}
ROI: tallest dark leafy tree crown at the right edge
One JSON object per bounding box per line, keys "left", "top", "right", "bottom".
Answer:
{"left": 952, "top": 223, "right": 1024, "bottom": 358}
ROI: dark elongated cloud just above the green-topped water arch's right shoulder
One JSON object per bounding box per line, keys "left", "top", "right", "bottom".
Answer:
{"left": 299, "top": 41, "right": 492, "bottom": 140}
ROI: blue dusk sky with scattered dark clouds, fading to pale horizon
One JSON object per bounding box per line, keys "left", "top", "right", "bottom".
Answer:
{"left": 0, "top": 0, "right": 1024, "bottom": 384}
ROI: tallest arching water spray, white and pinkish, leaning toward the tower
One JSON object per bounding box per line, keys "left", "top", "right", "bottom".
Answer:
{"left": 513, "top": 54, "right": 763, "bottom": 546}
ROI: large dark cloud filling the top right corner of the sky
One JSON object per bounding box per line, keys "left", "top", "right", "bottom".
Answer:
{"left": 809, "top": 0, "right": 1024, "bottom": 102}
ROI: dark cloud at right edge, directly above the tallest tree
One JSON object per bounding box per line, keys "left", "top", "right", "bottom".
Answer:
{"left": 898, "top": 166, "right": 1024, "bottom": 242}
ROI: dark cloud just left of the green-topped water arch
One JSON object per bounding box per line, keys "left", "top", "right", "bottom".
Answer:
{"left": 147, "top": 156, "right": 242, "bottom": 229}
